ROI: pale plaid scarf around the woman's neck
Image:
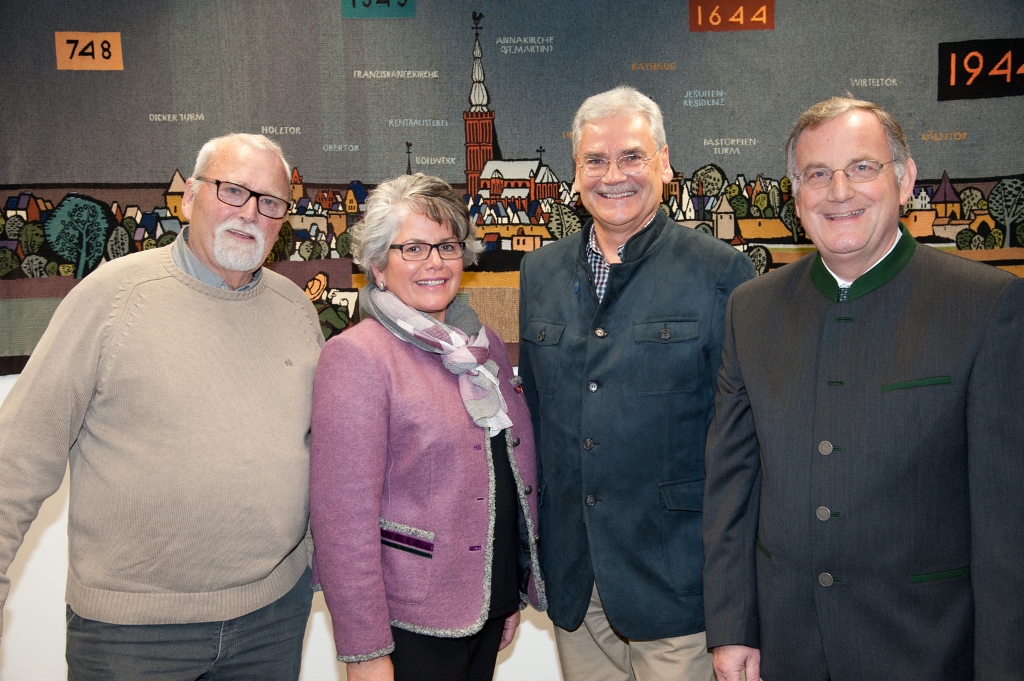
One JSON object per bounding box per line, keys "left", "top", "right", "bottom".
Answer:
{"left": 359, "top": 285, "right": 520, "bottom": 433}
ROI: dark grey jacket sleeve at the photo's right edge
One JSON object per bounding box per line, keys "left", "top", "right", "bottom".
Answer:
{"left": 967, "top": 279, "right": 1024, "bottom": 681}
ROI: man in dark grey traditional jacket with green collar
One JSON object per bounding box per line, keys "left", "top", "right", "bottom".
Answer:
{"left": 703, "top": 98, "right": 1024, "bottom": 681}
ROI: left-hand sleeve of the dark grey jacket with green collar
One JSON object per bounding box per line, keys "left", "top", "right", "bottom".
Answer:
{"left": 703, "top": 290, "right": 761, "bottom": 648}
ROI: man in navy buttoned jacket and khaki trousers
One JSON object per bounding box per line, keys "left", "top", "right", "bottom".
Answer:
{"left": 519, "top": 87, "right": 754, "bottom": 681}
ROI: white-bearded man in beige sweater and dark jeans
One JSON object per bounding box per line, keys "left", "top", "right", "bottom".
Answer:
{"left": 0, "top": 134, "right": 324, "bottom": 681}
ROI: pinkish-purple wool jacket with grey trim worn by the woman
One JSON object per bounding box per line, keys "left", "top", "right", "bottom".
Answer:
{"left": 309, "top": 320, "right": 546, "bottom": 662}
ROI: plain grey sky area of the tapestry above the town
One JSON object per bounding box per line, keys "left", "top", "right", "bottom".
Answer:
{"left": 0, "top": 0, "right": 1024, "bottom": 185}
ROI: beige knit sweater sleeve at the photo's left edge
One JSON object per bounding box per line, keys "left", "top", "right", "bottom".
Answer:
{"left": 0, "top": 270, "right": 118, "bottom": 628}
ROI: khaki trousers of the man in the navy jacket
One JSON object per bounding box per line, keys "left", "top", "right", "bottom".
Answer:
{"left": 555, "top": 584, "right": 715, "bottom": 681}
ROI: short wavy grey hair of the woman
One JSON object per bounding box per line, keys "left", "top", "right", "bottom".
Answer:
{"left": 351, "top": 173, "right": 483, "bottom": 284}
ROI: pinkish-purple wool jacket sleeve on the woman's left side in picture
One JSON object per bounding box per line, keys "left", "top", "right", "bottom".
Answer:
{"left": 309, "top": 333, "right": 394, "bottom": 662}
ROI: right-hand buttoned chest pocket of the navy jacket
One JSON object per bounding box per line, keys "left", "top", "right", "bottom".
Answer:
{"left": 633, "top": 317, "right": 708, "bottom": 395}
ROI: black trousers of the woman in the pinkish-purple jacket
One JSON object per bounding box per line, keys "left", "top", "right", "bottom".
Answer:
{"left": 391, "top": 618, "right": 505, "bottom": 681}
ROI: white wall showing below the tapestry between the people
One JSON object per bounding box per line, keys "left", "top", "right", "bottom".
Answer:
{"left": 0, "top": 376, "right": 561, "bottom": 681}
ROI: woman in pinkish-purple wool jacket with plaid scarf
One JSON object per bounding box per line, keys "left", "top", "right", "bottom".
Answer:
{"left": 309, "top": 174, "right": 545, "bottom": 681}
